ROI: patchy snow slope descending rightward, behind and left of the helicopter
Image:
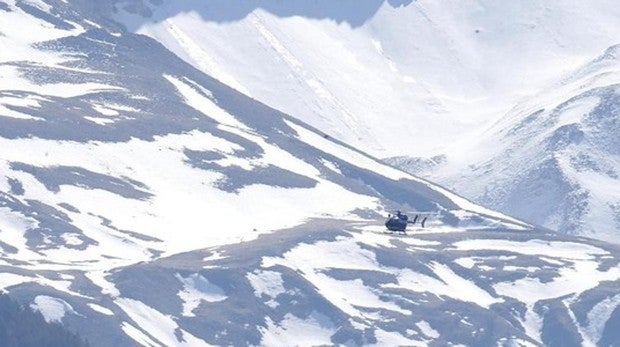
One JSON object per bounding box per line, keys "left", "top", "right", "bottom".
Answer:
{"left": 0, "top": 0, "right": 521, "bottom": 264}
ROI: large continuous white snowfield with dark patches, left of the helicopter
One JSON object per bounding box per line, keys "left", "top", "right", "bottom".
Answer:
{"left": 0, "top": 132, "right": 378, "bottom": 268}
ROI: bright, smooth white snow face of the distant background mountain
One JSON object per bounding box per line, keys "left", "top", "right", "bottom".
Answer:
{"left": 119, "top": 0, "right": 620, "bottom": 157}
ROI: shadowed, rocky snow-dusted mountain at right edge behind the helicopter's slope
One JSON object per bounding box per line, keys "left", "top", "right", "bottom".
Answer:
{"left": 389, "top": 46, "right": 620, "bottom": 243}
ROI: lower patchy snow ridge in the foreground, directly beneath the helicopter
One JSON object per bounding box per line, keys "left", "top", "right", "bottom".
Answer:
{"left": 6, "top": 220, "right": 620, "bottom": 346}
